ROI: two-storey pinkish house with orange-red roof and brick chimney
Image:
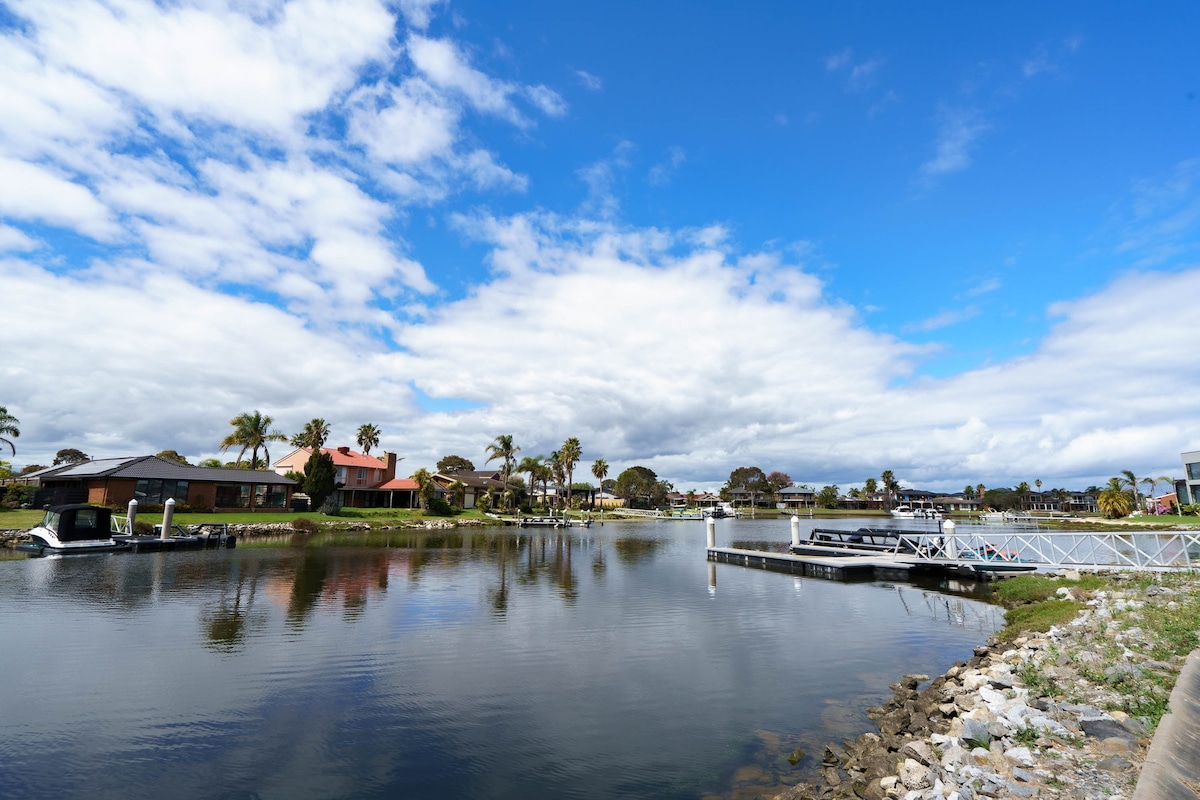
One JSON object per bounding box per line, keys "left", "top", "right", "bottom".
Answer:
{"left": 272, "top": 446, "right": 418, "bottom": 509}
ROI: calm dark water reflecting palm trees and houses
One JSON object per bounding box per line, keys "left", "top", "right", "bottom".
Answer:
{"left": 0, "top": 521, "right": 1002, "bottom": 799}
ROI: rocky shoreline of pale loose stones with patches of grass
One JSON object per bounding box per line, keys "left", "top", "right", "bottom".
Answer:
{"left": 763, "top": 583, "right": 1194, "bottom": 800}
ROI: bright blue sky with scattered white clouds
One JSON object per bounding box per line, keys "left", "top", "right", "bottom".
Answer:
{"left": 0, "top": 0, "right": 1200, "bottom": 491}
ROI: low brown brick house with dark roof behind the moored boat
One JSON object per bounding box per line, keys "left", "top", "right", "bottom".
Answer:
{"left": 14, "top": 456, "right": 296, "bottom": 511}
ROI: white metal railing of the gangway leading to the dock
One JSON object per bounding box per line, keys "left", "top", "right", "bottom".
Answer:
{"left": 896, "top": 530, "right": 1200, "bottom": 571}
